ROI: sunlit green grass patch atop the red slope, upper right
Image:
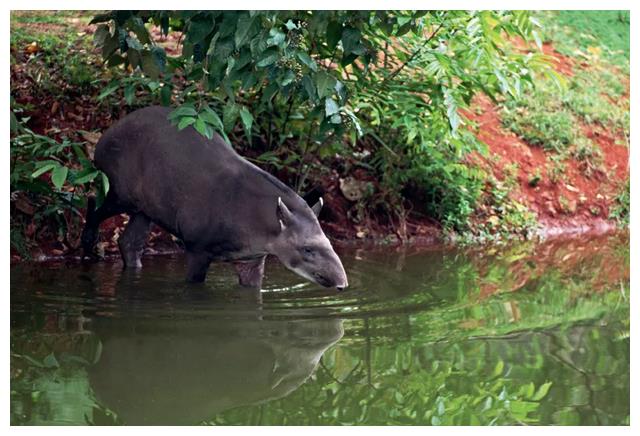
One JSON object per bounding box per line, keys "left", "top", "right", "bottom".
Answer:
{"left": 501, "top": 11, "right": 629, "bottom": 183}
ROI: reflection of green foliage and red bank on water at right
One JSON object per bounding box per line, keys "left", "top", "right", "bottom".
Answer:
{"left": 206, "top": 238, "right": 629, "bottom": 425}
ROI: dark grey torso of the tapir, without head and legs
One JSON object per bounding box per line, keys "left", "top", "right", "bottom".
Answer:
{"left": 95, "top": 106, "right": 306, "bottom": 249}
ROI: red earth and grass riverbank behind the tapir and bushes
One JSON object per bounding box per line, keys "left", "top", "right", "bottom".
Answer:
{"left": 11, "top": 12, "right": 629, "bottom": 262}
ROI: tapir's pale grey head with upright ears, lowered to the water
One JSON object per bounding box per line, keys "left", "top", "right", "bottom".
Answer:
{"left": 269, "top": 198, "right": 348, "bottom": 290}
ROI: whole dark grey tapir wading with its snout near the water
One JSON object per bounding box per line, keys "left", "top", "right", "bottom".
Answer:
{"left": 82, "top": 106, "right": 347, "bottom": 290}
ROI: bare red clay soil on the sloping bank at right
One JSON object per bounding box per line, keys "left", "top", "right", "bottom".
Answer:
{"left": 465, "top": 44, "right": 629, "bottom": 235}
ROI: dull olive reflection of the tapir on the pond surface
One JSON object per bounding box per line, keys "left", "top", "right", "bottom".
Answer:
{"left": 89, "top": 317, "right": 343, "bottom": 425}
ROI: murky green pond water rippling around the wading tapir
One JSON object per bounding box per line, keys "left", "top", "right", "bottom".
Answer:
{"left": 11, "top": 234, "right": 629, "bottom": 425}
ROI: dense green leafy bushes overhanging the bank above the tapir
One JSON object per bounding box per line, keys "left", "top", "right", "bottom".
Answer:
{"left": 94, "top": 11, "right": 553, "bottom": 229}
